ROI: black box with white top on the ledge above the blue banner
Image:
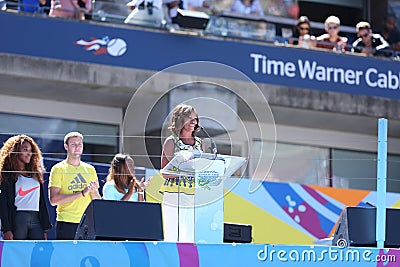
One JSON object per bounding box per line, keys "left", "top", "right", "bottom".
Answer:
{"left": 172, "top": 9, "right": 210, "bottom": 30}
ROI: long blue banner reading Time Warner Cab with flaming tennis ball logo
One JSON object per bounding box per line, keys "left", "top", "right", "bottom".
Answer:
{"left": 0, "top": 12, "right": 400, "bottom": 99}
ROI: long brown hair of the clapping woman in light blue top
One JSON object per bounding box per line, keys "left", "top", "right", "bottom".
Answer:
{"left": 107, "top": 153, "right": 139, "bottom": 194}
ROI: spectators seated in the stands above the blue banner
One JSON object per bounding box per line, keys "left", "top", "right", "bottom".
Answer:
{"left": 0, "top": 0, "right": 400, "bottom": 57}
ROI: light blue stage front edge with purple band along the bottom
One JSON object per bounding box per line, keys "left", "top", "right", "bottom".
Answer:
{"left": 0, "top": 241, "right": 400, "bottom": 267}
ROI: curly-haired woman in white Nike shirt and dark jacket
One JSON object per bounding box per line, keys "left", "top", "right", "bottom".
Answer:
{"left": 0, "top": 135, "right": 52, "bottom": 240}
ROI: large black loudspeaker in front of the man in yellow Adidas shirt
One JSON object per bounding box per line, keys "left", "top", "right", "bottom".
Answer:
{"left": 75, "top": 199, "right": 164, "bottom": 241}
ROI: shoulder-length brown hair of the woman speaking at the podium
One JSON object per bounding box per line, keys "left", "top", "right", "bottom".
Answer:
{"left": 168, "top": 104, "right": 200, "bottom": 137}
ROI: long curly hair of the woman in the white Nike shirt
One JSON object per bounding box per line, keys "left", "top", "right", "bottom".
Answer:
{"left": 0, "top": 135, "right": 44, "bottom": 184}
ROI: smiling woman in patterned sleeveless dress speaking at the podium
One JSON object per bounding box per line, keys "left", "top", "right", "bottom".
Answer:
{"left": 160, "top": 104, "right": 205, "bottom": 242}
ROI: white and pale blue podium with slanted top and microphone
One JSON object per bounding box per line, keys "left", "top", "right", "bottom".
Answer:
{"left": 161, "top": 150, "right": 246, "bottom": 243}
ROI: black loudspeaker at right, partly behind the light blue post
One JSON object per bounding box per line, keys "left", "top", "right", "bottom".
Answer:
{"left": 332, "top": 207, "right": 400, "bottom": 248}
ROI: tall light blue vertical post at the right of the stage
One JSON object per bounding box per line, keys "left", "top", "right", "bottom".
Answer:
{"left": 376, "top": 119, "right": 387, "bottom": 248}
